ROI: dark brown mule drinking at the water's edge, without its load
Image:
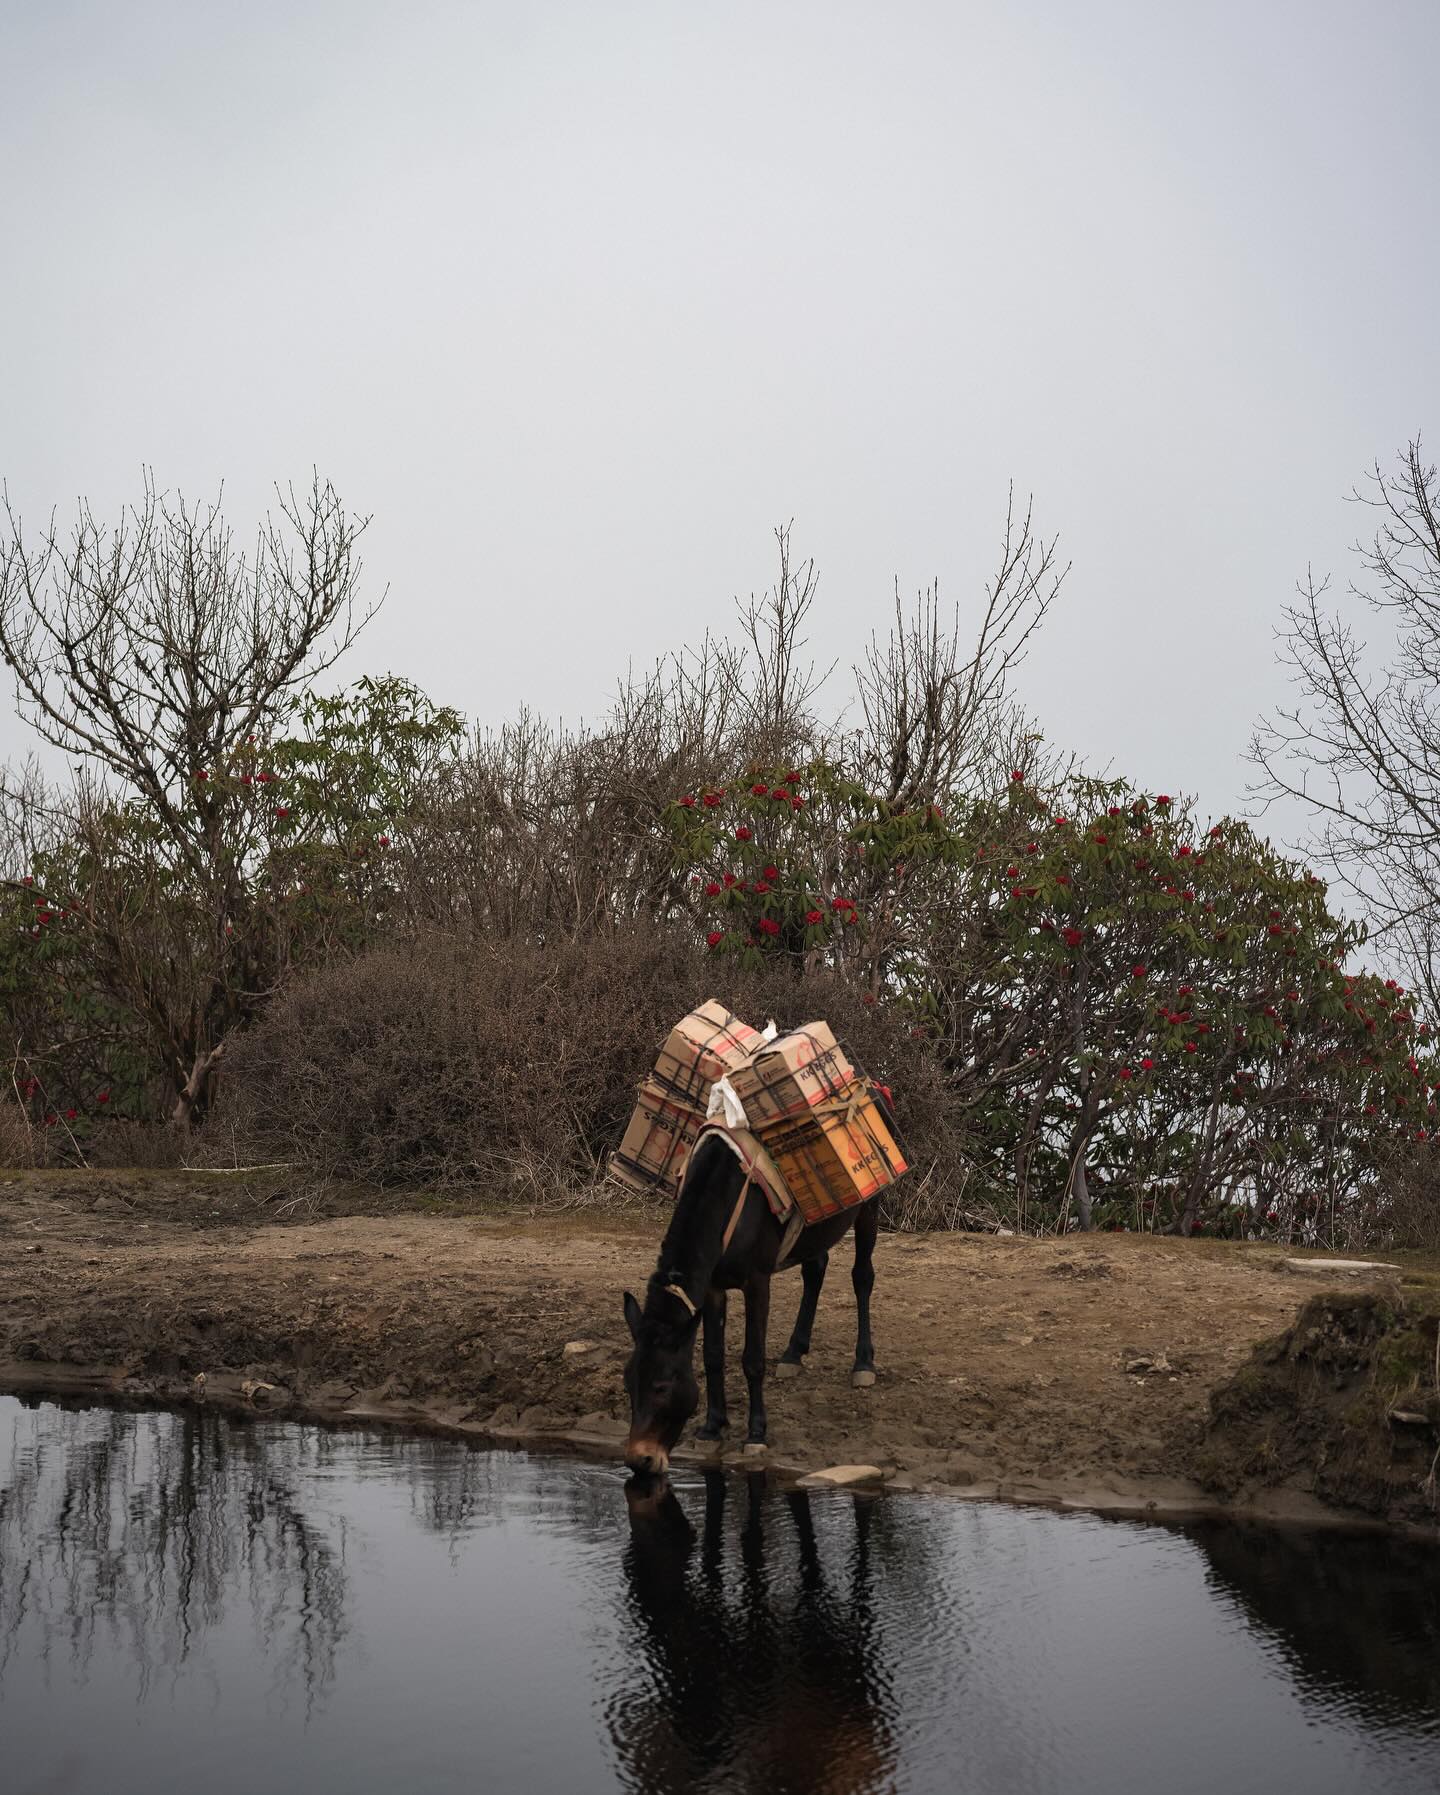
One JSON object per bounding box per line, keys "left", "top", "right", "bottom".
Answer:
{"left": 625, "top": 1136, "right": 880, "bottom": 1472}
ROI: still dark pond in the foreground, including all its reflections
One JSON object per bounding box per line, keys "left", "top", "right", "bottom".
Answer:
{"left": 0, "top": 1398, "right": 1440, "bottom": 1795}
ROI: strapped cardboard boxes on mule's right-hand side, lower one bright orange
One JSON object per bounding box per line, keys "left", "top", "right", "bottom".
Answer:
{"left": 731, "top": 1021, "right": 907, "bottom": 1222}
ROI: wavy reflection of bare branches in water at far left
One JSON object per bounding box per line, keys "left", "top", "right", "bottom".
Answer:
{"left": 0, "top": 1404, "right": 347, "bottom": 1700}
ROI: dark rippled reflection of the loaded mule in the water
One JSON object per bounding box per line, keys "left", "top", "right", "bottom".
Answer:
{"left": 607, "top": 1472, "right": 896, "bottom": 1795}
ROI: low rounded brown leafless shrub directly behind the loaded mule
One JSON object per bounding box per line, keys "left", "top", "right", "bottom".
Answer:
{"left": 199, "top": 930, "right": 966, "bottom": 1221}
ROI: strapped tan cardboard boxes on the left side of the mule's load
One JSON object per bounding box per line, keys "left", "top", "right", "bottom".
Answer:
{"left": 610, "top": 998, "right": 763, "bottom": 1195}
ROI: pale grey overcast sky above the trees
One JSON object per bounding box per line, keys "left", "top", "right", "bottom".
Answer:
{"left": 0, "top": 0, "right": 1440, "bottom": 825}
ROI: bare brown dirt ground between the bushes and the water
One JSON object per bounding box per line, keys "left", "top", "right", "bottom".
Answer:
{"left": 0, "top": 1172, "right": 1422, "bottom": 1515}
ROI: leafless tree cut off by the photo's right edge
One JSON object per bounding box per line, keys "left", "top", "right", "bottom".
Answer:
{"left": 1251, "top": 436, "right": 1440, "bottom": 1005}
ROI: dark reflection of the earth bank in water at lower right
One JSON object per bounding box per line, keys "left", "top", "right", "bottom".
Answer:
{"left": 1185, "top": 1520, "right": 1440, "bottom": 1723}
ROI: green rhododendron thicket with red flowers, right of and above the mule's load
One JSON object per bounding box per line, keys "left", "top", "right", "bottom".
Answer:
{"left": 666, "top": 761, "right": 1440, "bottom": 1237}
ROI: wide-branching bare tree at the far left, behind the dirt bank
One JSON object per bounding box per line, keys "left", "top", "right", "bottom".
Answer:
{"left": 0, "top": 477, "right": 368, "bottom": 1124}
